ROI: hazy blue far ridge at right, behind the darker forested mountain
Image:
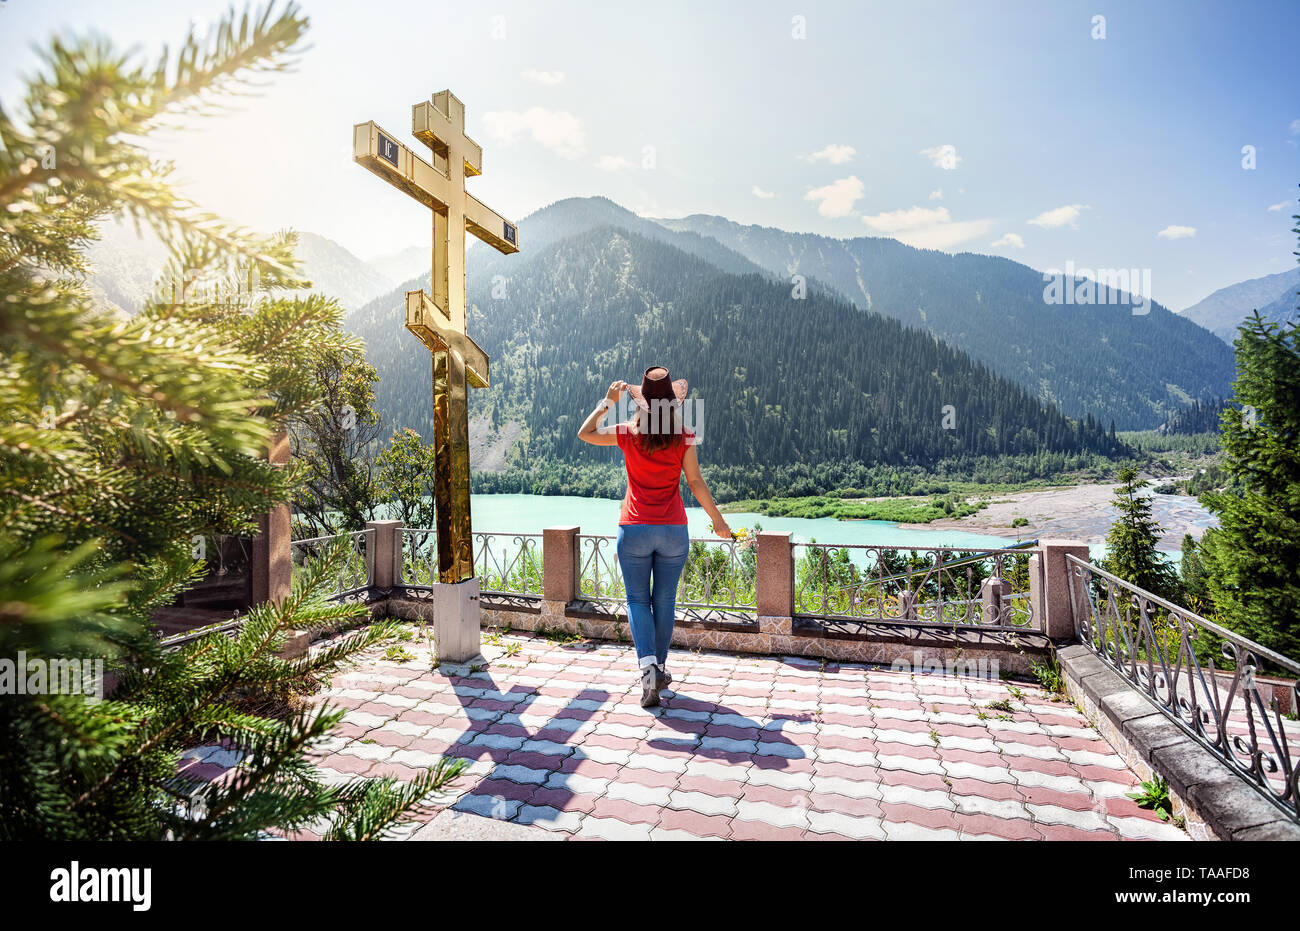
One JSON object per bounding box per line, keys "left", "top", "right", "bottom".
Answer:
{"left": 660, "top": 209, "right": 1234, "bottom": 429}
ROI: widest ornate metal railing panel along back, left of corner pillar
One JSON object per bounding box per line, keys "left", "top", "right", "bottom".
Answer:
{"left": 792, "top": 541, "right": 1043, "bottom": 631}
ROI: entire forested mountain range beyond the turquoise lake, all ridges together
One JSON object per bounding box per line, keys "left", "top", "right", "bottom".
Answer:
{"left": 92, "top": 198, "right": 1294, "bottom": 486}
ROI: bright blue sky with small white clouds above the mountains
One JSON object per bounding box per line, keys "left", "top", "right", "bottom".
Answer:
{"left": 0, "top": 0, "right": 1300, "bottom": 309}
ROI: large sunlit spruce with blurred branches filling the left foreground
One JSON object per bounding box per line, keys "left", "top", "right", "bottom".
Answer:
{"left": 0, "top": 4, "right": 459, "bottom": 839}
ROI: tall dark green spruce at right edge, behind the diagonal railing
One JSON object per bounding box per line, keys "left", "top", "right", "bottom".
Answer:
{"left": 1201, "top": 254, "right": 1300, "bottom": 658}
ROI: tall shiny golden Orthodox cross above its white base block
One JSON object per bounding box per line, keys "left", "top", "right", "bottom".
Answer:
{"left": 352, "top": 91, "right": 519, "bottom": 583}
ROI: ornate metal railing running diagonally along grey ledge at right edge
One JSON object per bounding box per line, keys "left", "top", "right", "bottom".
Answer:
{"left": 1066, "top": 555, "right": 1300, "bottom": 820}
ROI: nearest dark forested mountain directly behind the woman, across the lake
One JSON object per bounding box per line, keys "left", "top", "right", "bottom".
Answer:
{"left": 348, "top": 225, "right": 1123, "bottom": 491}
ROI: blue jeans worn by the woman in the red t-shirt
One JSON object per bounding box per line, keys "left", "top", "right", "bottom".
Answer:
{"left": 618, "top": 524, "right": 690, "bottom": 668}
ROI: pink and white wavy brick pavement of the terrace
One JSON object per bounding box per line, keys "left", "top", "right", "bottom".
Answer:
{"left": 191, "top": 635, "right": 1187, "bottom": 840}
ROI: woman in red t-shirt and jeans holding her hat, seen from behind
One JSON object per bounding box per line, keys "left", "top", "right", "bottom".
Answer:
{"left": 577, "top": 365, "right": 732, "bottom": 707}
